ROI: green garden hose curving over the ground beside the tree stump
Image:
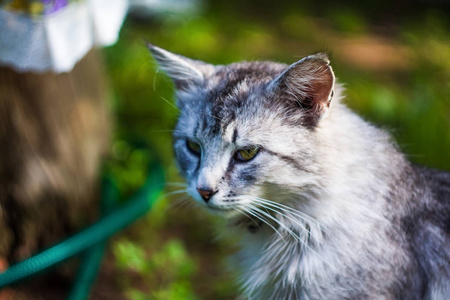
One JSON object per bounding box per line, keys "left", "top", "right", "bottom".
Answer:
{"left": 0, "top": 151, "right": 164, "bottom": 299}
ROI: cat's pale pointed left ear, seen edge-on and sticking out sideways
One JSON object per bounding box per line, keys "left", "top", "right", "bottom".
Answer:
{"left": 147, "top": 42, "right": 214, "bottom": 90}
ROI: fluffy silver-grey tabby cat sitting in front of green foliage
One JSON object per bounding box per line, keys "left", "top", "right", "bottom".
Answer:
{"left": 148, "top": 44, "right": 450, "bottom": 300}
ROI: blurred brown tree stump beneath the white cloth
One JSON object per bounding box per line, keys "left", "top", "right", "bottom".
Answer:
{"left": 0, "top": 50, "right": 110, "bottom": 296}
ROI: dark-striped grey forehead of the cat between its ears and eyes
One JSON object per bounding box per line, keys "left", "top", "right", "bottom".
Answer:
{"left": 178, "top": 62, "right": 286, "bottom": 142}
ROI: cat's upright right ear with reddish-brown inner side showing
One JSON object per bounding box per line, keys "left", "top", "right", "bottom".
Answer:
{"left": 270, "top": 53, "right": 335, "bottom": 125}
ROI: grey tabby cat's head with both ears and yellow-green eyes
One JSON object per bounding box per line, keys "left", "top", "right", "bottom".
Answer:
{"left": 149, "top": 45, "right": 335, "bottom": 216}
